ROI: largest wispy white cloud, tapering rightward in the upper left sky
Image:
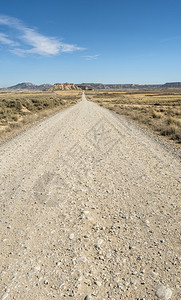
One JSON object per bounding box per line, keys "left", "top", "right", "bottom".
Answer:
{"left": 0, "top": 15, "right": 84, "bottom": 56}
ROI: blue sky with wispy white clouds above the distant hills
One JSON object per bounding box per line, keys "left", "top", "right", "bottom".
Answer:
{"left": 0, "top": 0, "right": 181, "bottom": 87}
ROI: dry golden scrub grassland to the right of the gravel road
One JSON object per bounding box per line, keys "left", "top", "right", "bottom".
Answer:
{"left": 86, "top": 90, "right": 181, "bottom": 143}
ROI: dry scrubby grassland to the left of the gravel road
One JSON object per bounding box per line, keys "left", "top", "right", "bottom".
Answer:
{"left": 0, "top": 91, "right": 81, "bottom": 142}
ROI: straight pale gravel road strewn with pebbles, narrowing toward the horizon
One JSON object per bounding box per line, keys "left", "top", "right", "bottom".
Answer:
{"left": 0, "top": 95, "right": 181, "bottom": 300}
